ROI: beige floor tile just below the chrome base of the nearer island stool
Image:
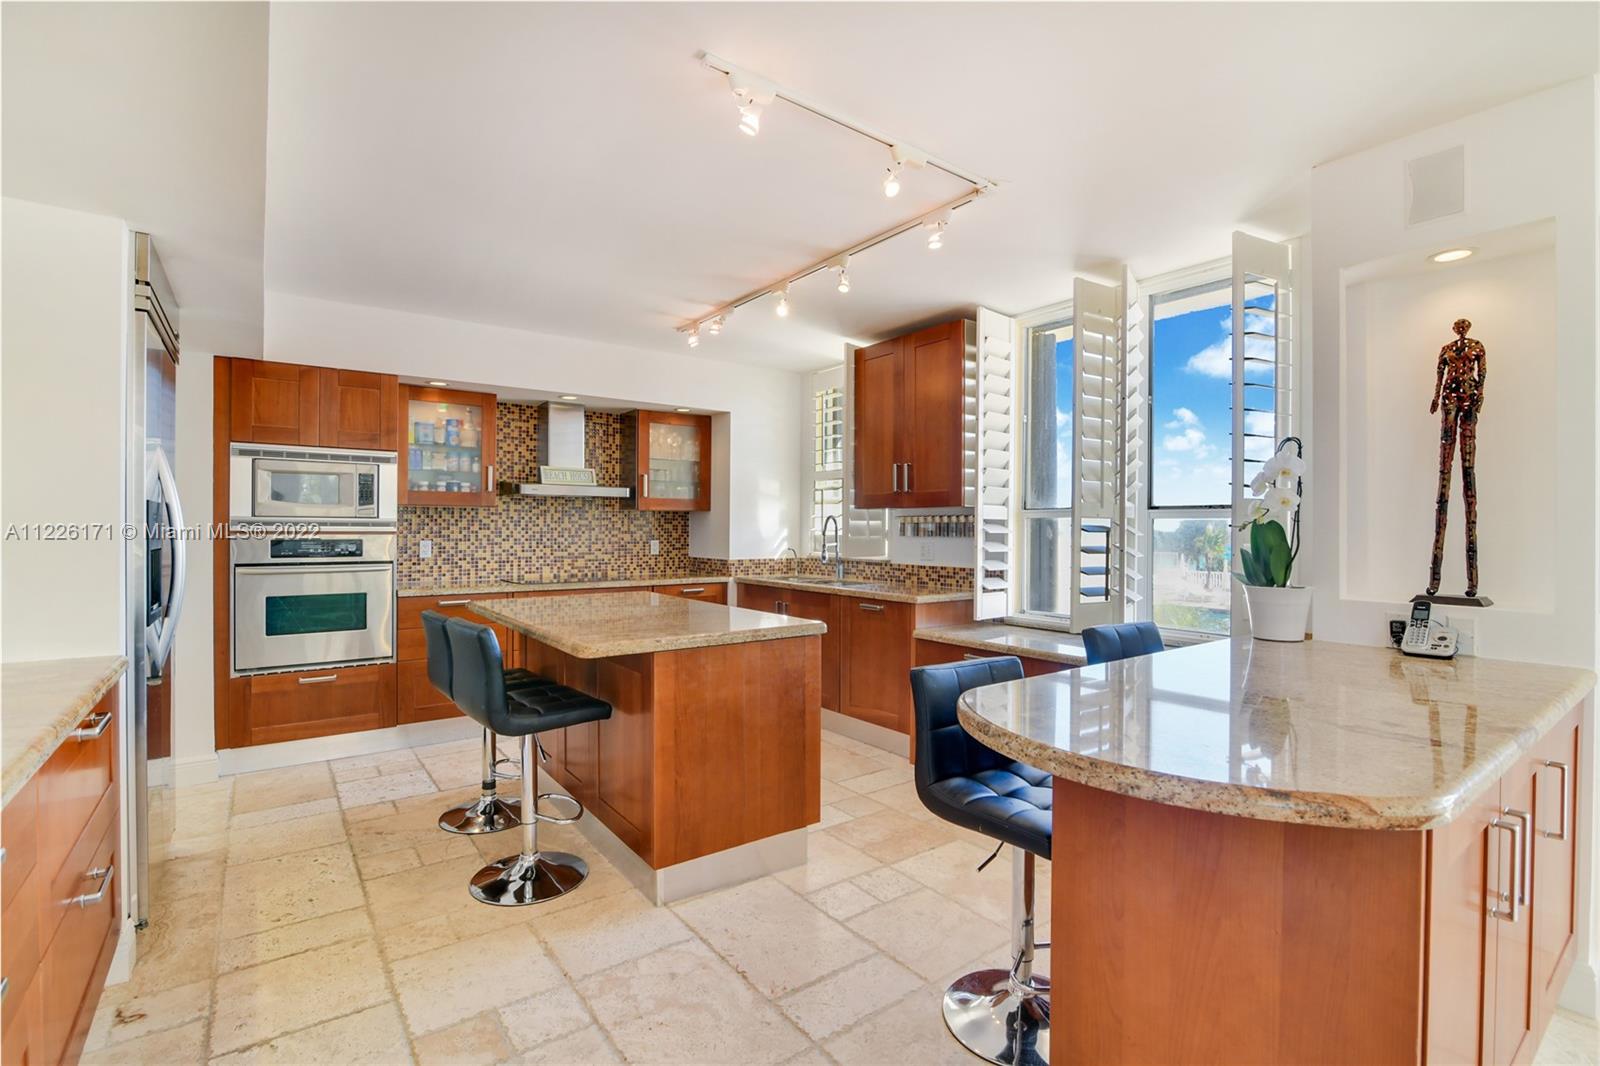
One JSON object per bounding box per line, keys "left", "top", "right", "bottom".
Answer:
{"left": 392, "top": 921, "right": 563, "bottom": 1036}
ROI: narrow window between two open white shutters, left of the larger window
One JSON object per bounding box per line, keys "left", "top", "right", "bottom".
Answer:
{"left": 1022, "top": 319, "right": 1074, "bottom": 618}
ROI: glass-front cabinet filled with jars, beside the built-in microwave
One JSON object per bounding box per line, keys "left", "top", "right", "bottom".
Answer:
{"left": 400, "top": 386, "right": 498, "bottom": 507}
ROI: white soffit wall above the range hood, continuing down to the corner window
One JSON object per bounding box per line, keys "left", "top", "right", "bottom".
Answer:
{"left": 264, "top": 291, "right": 812, "bottom": 559}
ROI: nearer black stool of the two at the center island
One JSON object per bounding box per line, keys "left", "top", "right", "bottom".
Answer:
{"left": 445, "top": 618, "right": 611, "bottom": 906}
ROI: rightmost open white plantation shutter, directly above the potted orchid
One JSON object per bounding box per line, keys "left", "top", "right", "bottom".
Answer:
{"left": 1232, "top": 232, "right": 1294, "bottom": 614}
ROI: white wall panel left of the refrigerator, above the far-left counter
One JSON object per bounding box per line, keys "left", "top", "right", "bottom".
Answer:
{"left": 0, "top": 198, "right": 133, "bottom": 659}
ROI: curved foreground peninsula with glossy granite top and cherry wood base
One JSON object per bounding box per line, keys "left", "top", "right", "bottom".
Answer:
{"left": 958, "top": 639, "right": 1595, "bottom": 1066}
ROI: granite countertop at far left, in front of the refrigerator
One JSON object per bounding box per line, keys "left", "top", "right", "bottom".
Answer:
{"left": 0, "top": 655, "right": 128, "bottom": 804}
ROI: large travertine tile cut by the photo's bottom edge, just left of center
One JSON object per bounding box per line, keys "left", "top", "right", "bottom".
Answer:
{"left": 578, "top": 940, "right": 806, "bottom": 1063}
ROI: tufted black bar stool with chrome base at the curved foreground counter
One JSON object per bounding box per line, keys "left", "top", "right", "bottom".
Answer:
{"left": 910, "top": 655, "right": 1053, "bottom": 1066}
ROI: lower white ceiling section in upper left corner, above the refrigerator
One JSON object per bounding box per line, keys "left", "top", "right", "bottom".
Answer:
{"left": 0, "top": 2, "right": 267, "bottom": 354}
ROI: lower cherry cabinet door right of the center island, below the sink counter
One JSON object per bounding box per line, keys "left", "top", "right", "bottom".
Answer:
{"left": 838, "top": 595, "right": 914, "bottom": 733}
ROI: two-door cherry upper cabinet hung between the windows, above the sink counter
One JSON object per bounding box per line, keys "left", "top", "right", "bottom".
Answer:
{"left": 853, "top": 320, "right": 968, "bottom": 507}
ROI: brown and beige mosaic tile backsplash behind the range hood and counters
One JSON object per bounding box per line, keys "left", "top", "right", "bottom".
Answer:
{"left": 398, "top": 403, "right": 973, "bottom": 592}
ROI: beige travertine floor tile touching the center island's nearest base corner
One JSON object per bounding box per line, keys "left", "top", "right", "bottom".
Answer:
{"left": 677, "top": 877, "right": 872, "bottom": 997}
